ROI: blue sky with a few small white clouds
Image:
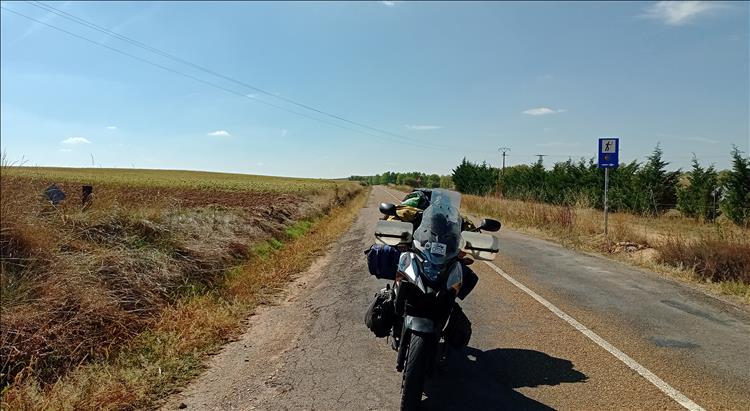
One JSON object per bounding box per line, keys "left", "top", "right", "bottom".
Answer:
{"left": 0, "top": 2, "right": 750, "bottom": 177}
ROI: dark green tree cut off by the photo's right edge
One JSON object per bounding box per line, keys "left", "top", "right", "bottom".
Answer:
{"left": 721, "top": 147, "right": 750, "bottom": 226}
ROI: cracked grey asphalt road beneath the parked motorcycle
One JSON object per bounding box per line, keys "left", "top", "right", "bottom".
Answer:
{"left": 164, "top": 187, "right": 750, "bottom": 410}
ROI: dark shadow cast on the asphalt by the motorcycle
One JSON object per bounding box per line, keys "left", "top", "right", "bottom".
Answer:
{"left": 422, "top": 347, "right": 588, "bottom": 410}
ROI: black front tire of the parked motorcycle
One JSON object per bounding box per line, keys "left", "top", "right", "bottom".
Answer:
{"left": 401, "top": 332, "right": 432, "bottom": 411}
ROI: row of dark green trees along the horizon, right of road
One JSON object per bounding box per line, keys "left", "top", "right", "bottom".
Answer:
{"left": 351, "top": 145, "right": 750, "bottom": 226}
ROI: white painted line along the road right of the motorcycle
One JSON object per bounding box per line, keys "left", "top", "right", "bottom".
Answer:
{"left": 485, "top": 261, "right": 705, "bottom": 411}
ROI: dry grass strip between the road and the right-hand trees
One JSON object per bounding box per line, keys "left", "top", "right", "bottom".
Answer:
{"left": 462, "top": 195, "right": 750, "bottom": 303}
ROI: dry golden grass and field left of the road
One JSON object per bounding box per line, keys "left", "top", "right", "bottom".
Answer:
{"left": 0, "top": 168, "right": 359, "bottom": 409}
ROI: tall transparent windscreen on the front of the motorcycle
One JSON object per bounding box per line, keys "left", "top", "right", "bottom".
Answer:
{"left": 414, "top": 190, "right": 461, "bottom": 270}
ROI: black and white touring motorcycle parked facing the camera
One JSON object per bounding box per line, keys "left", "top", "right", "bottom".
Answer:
{"left": 368, "top": 189, "right": 500, "bottom": 410}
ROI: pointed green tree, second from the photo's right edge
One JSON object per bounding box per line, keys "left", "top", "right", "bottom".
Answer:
{"left": 677, "top": 156, "right": 719, "bottom": 220}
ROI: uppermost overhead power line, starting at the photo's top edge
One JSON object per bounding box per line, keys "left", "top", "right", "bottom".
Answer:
{"left": 26, "top": 1, "right": 447, "bottom": 148}
